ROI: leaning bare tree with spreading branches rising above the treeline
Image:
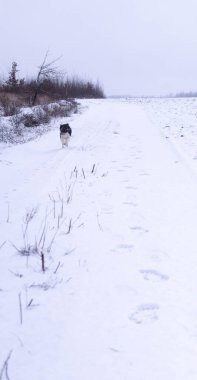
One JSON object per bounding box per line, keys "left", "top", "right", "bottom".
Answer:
{"left": 32, "top": 51, "right": 63, "bottom": 106}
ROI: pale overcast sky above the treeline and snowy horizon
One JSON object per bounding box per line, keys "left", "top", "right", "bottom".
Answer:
{"left": 0, "top": 0, "right": 197, "bottom": 96}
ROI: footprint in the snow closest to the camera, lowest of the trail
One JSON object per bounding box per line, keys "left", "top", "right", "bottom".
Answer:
{"left": 129, "top": 303, "right": 160, "bottom": 325}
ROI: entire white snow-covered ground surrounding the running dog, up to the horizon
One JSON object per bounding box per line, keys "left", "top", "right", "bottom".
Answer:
{"left": 0, "top": 99, "right": 197, "bottom": 380}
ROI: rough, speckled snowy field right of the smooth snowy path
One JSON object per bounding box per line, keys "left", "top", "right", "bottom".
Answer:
{"left": 142, "top": 98, "right": 197, "bottom": 171}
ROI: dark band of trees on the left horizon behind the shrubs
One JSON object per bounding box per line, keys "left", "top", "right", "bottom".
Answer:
{"left": 0, "top": 61, "right": 104, "bottom": 105}
